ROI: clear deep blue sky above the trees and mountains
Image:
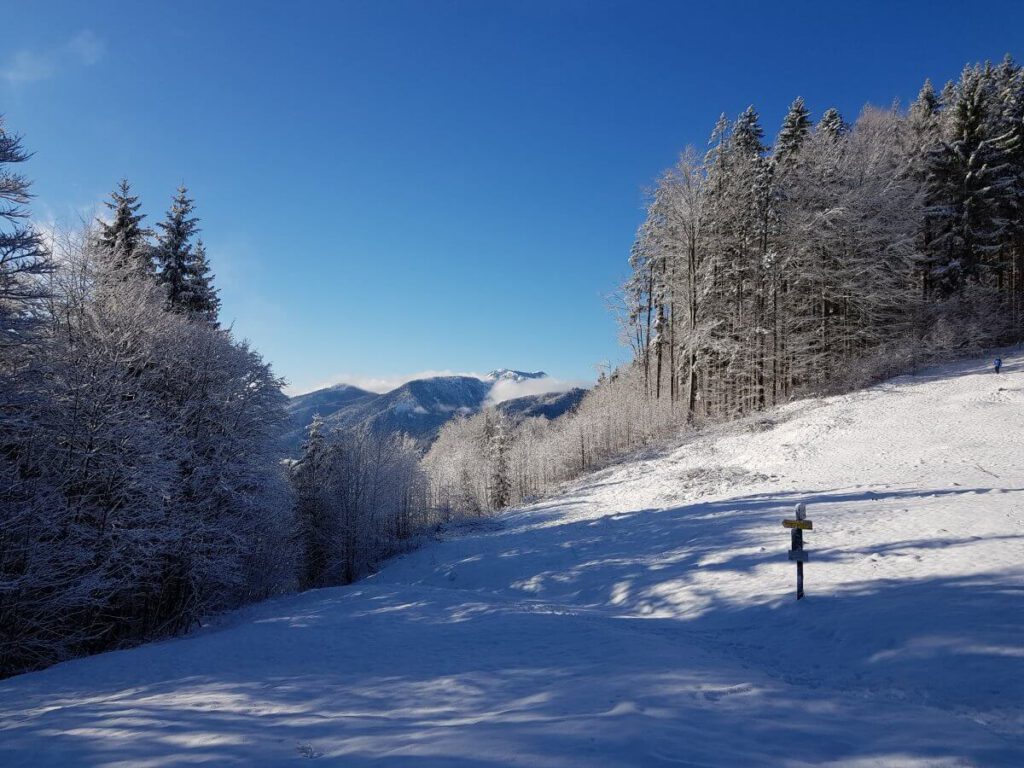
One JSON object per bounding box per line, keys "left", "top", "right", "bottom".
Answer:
{"left": 0, "top": 0, "right": 1024, "bottom": 389}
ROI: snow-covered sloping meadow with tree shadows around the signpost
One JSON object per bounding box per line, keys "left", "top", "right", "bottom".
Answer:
{"left": 0, "top": 358, "right": 1024, "bottom": 768}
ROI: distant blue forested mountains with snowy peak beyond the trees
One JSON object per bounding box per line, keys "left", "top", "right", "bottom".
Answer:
{"left": 285, "top": 369, "right": 586, "bottom": 456}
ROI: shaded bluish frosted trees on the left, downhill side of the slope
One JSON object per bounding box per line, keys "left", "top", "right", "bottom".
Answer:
{"left": 0, "top": 117, "right": 425, "bottom": 677}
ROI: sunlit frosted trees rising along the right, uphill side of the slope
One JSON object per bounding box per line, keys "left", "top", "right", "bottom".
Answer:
{"left": 424, "top": 57, "right": 1024, "bottom": 515}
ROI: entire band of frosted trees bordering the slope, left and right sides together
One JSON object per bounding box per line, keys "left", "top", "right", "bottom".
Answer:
{"left": 0, "top": 58, "right": 1024, "bottom": 676}
